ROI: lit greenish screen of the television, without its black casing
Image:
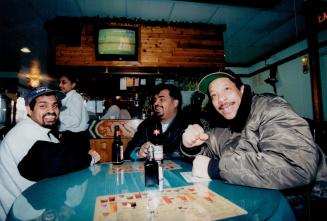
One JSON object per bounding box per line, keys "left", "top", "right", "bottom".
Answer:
{"left": 98, "top": 28, "right": 136, "bottom": 55}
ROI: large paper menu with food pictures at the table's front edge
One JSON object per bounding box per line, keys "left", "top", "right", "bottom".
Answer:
{"left": 93, "top": 184, "right": 247, "bottom": 221}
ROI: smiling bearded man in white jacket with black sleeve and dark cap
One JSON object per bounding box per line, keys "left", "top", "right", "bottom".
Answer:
{"left": 0, "top": 87, "right": 100, "bottom": 220}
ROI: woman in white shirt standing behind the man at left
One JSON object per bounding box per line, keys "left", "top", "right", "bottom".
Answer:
{"left": 59, "top": 74, "right": 90, "bottom": 155}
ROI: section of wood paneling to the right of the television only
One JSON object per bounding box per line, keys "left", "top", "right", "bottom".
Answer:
{"left": 140, "top": 27, "right": 224, "bottom": 67}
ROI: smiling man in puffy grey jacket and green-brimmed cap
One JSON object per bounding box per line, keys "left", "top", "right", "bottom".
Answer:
{"left": 180, "top": 70, "right": 326, "bottom": 193}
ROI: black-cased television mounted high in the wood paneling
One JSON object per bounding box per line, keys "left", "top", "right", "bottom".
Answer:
{"left": 95, "top": 26, "right": 138, "bottom": 61}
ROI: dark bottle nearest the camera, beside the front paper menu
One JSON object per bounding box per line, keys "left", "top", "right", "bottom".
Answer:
{"left": 144, "top": 145, "right": 159, "bottom": 186}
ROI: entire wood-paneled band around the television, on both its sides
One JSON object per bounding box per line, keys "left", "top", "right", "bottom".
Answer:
{"left": 49, "top": 20, "right": 224, "bottom": 68}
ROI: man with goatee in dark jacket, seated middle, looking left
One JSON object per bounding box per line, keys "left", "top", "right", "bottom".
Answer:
{"left": 125, "top": 84, "right": 186, "bottom": 160}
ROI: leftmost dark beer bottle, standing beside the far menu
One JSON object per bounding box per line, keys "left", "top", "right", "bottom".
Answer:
{"left": 111, "top": 125, "right": 124, "bottom": 165}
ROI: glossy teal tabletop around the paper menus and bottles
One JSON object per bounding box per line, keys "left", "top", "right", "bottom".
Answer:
{"left": 8, "top": 161, "right": 295, "bottom": 221}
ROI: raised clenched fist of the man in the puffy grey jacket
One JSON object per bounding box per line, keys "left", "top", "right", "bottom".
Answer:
{"left": 182, "top": 124, "right": 209, "bottom": 148}
